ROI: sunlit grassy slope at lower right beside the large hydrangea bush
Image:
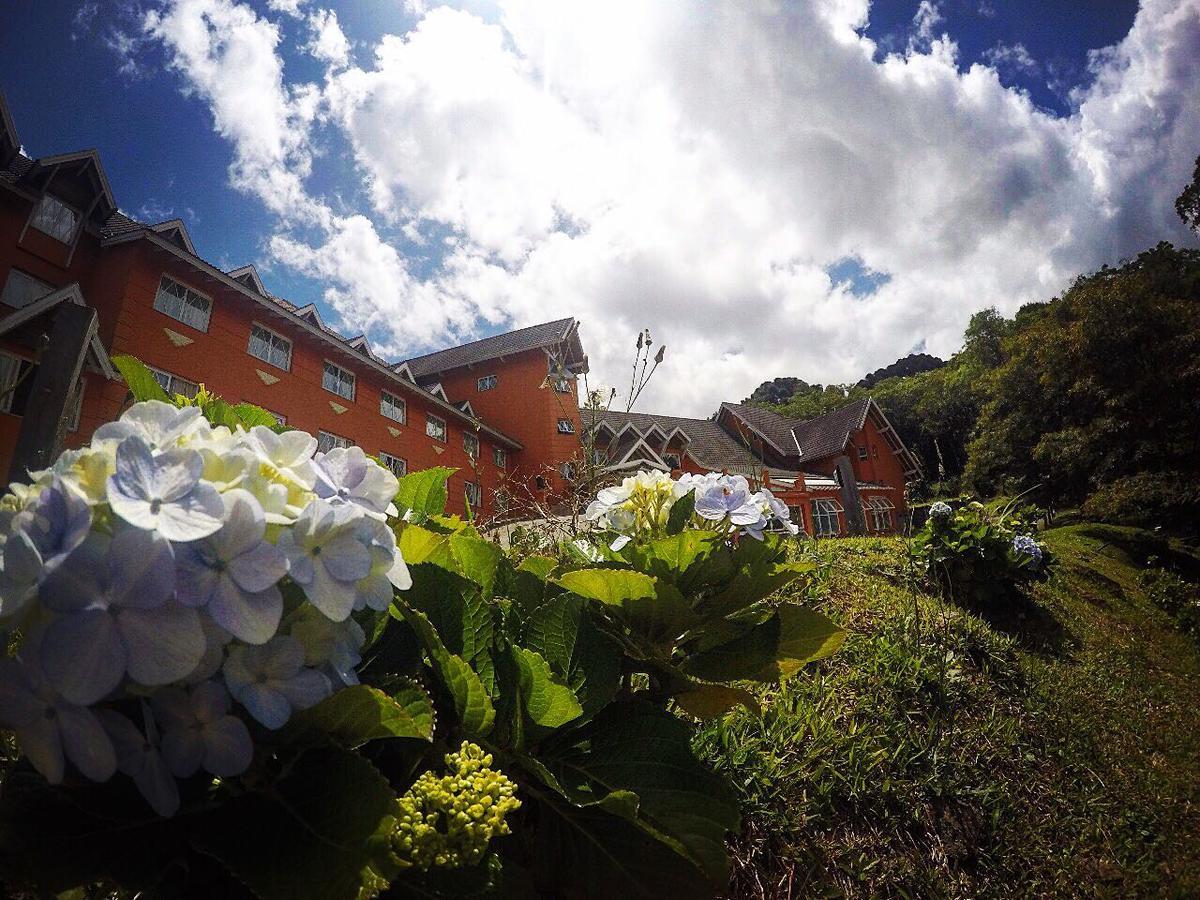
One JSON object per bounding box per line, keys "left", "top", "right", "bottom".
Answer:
{"left": 697, "top": 524, "right": 1200, "bottom": 898}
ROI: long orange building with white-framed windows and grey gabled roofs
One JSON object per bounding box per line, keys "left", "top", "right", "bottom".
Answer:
{"left": 0, "top": 95, "right": 916, "bottom": 534}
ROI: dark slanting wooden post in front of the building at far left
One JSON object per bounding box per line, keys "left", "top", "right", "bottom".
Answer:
{"left": 8, "top": 304, "right": 97, "bottom": 481}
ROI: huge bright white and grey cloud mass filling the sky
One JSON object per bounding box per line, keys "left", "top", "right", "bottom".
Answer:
{"left": 133, "top": 0, "right": 1200, "bottom": 414}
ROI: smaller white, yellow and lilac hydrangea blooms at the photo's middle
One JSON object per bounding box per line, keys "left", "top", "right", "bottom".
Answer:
{"left": 584, "top": 472, "right": 799, "bottom": 550}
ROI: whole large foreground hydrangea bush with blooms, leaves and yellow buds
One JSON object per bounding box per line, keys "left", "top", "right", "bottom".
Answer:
{"left": 0, "top": 358, "right": 842, "bottom": 900}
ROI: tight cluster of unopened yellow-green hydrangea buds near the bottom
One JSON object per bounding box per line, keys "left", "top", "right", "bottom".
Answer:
{"left": 391, "top": 740, "right": 521, "bottom": 870}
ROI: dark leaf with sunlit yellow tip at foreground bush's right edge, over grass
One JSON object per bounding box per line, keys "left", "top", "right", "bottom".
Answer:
{"left": 683, "top": 604, "right": 846, "bottom": 682}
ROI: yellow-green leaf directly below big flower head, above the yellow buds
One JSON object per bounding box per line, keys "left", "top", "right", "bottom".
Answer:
{"left": 283, "top": 684, "right": 436, "bottom": 748}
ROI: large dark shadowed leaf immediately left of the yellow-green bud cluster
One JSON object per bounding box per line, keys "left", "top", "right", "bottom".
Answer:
{"left": 193, "top": 746, "right": 396, "bottom": 900}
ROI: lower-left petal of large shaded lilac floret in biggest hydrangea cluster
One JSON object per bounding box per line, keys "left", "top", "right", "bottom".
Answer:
{"left": 40, "top": 610, "right": 127, "bottom": 706}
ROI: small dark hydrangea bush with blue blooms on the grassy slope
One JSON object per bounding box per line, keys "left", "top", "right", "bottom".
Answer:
{"left": 913, "top": 500, "right": 1054, "bottom": 605}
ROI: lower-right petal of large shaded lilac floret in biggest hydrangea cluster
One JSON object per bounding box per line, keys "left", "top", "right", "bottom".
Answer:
{"left": 118, "top": 604, "right": 205, "bottom": 686}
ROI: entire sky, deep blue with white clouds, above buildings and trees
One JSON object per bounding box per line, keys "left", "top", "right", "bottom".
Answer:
{"left": 0, "top": 0, "right": 1185, "bottom": 409}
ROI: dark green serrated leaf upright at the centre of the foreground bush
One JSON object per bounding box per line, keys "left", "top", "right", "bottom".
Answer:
{"left": 522, "top": 594, "right": 620, "bottom": 718}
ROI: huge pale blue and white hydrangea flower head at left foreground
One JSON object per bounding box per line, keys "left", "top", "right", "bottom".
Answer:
{"left": 0, "top": 401, "right": 412, "bottom": 816}
